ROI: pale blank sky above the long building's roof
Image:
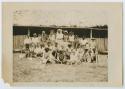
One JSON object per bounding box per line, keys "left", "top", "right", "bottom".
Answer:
{"left": 13, "top": 3, "right": 107, "bottom": 27}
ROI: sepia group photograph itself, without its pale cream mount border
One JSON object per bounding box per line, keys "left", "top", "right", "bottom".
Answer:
{"left": 12, "top": 4, "right": 109, "bottom": 82}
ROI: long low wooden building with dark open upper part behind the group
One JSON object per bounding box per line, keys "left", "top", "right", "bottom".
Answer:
{"left": 13, "top": 26, "right": 108, "bottom": 52}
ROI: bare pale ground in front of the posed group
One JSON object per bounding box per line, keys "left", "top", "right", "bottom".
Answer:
{"left": 13, "top": 53, "right": 108, "bottom": 82}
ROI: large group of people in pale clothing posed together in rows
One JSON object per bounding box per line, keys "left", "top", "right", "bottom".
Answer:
{"left": 21, "top": 29, "right": 98, "bottom": 64}
